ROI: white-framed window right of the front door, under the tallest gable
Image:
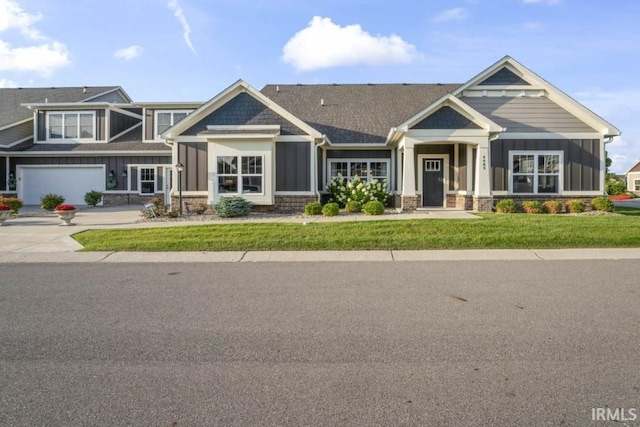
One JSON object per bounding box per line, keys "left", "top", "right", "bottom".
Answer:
{"left": 509, "top": 151, "right": 563, "bottom": 194}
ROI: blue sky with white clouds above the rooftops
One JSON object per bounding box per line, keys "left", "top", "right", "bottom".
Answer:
{"left": 0, "top": 0, "right": 640, "bottom": 173}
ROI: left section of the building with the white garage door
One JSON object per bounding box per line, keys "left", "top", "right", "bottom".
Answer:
{"left": 0, "top": 86, "right": 173, "bottom": 205}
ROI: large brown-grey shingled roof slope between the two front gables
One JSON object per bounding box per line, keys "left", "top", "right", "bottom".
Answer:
{"left": 261, "top": 84, "right": 460, "bottom": 144}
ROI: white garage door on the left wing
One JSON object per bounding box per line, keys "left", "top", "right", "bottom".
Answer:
{"left": 18, "top": 165, "right": 105, "bottom": 205}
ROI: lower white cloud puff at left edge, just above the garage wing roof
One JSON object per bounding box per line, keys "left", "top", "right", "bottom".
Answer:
{"left": 0, "top": 40, "right": 69, "bottom": 75}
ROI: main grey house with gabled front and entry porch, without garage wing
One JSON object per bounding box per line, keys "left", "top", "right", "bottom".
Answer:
{"left": 161, "top": 56, "right": 620, "bottom": 211}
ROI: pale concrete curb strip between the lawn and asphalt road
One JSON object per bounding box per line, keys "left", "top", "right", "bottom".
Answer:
{"left": 0, "top": 248, "right": 640, "bottom": 264}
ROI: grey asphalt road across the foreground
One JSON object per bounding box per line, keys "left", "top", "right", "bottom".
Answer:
{"left": 0, "top": 260, "right": 640, "bottom": 426}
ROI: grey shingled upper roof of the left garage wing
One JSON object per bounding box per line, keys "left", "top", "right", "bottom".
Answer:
{"left": 0, "top": 86, "right": 119, "bottom": 127}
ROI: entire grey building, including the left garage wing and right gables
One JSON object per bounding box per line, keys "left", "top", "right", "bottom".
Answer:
{"left": 0, "top": 56, "right": 620, "bottom": 211}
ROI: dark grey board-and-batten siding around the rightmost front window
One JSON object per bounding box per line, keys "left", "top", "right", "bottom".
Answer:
{"left": 491, "top": 139, "right": 603, "bottom": 191}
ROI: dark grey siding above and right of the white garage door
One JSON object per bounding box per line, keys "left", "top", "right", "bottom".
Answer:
{"left": 9, "top": 156, "right": 171, "bottom": 191}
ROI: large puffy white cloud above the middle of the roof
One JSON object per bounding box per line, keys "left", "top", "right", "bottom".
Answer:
{"left": 282, "top": 16, "right": 418, "bottom": 71}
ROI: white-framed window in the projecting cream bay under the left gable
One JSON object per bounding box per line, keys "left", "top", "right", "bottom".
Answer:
{"left": 216, "top": 156, "right": 264, "bottom": 194}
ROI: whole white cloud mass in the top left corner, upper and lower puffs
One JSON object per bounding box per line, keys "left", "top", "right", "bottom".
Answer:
{"left": 0, "top": 0, "right": 70, "bottom": 75}
